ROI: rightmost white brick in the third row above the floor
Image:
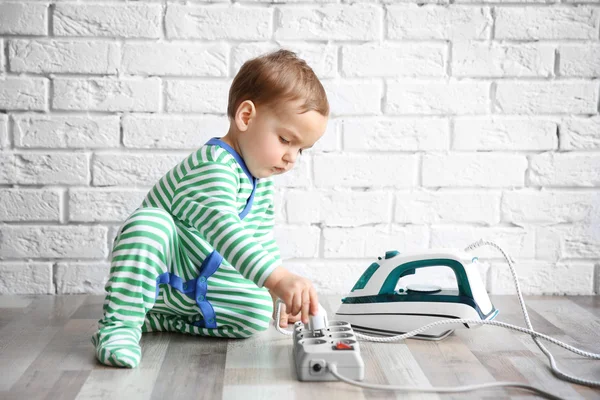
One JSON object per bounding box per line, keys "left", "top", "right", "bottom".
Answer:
{"left": 502, "top": 189, "right": 600, "bottom": 225}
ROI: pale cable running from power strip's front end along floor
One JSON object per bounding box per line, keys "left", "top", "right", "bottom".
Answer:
{"left": 327, "top": 363, "right": 562, "bottom": 400}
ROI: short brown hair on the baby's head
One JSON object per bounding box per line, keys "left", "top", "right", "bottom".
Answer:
{"left": 227, "top": 49, "right": 329, "bottom": 120}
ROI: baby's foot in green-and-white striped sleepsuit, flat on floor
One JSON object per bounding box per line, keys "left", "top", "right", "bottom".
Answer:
{"left": 92, "top": 326, "right": 142, "bottom": 368}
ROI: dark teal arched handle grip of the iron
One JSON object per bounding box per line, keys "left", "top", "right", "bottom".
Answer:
{"left": 380, "top": 258, "right": 473, "bottom": 299}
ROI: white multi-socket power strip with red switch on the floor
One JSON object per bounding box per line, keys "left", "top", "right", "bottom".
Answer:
{"left": 293, "top": 321, "right": 365, "bottom": 381}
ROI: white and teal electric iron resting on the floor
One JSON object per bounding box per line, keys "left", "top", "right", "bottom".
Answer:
{"left": 336, "top": 249, "right": 498, "bottom": 340}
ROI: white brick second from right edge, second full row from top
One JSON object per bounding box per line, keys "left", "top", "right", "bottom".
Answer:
{"left": 452, "top": 42, "right": 554, "bottom": 77}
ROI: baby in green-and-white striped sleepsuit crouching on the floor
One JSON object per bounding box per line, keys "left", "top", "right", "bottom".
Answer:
{"left": 92, "top": 50, "right": 329, "bottom": 368}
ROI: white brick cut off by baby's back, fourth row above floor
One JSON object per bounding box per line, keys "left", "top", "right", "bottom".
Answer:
{"left": 92, "top": 153, "right": 188, "bottom": 187}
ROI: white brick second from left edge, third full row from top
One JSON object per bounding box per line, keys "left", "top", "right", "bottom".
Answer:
{"left": 52, "top": 78, "right": 161, "bottom": 112}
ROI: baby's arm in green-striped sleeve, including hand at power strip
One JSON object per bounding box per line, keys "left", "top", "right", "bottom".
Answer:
{"left": 171, "top": 162, "right": 318, "bottom": 323}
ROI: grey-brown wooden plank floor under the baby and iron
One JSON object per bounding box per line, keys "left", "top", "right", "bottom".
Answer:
{"left": 0, "top": 296, "right": 600, "bottom": 400}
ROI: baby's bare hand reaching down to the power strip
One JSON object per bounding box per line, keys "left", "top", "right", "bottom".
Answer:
{"left": 265, "top": 267, "right": 319, "bottom": 326}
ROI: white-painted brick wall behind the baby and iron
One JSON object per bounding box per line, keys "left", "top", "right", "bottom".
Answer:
{"left": 0, "top": 0, "right": 600, "bottom": 294}
